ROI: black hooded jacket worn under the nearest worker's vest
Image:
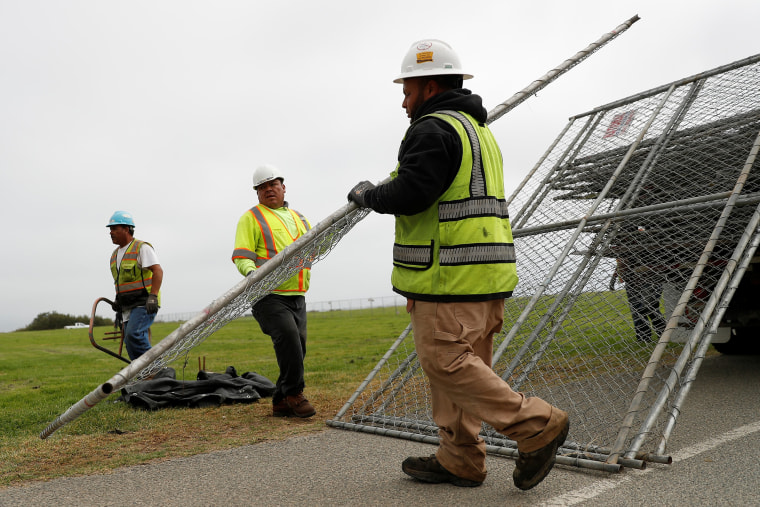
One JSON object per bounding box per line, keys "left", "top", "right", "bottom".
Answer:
{"left": 365, "top": 88, "right": 488, "bottom": 215}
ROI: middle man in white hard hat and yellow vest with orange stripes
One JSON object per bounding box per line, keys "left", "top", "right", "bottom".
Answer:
{"left": 232, "top": 164, "right": 316, "bottom": 418}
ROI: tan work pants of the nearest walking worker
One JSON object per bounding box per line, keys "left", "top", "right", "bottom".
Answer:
{"left": 409, "top": 299, "right": 561, "bottom": 481}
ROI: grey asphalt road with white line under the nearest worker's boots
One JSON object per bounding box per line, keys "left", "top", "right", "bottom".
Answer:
{"left": 0, "top": 356, "right": 760, "bottom": 506}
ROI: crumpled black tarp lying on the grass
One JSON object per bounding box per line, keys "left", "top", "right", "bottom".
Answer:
{"left": 119, "top": 366, "right": 275, "bottom": 410}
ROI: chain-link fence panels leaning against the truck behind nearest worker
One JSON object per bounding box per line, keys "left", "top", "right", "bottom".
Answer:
{"left": 328, "top": 55, "right": 760, "bottom": 466}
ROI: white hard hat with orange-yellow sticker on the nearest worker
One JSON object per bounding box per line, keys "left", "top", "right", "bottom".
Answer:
{"left": 393, "top": 39, "right": 472, "bottom": 83}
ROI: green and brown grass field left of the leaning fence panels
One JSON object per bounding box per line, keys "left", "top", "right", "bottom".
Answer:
{"left": 0, "top": 308, "right": 409, "bottom": 488}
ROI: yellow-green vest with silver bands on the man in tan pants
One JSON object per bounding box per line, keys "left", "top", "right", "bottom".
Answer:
{"left": 391, "top": 111, "right": 517, "bottom": 301}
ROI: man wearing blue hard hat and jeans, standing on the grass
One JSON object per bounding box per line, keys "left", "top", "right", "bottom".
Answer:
{"left": 106, "top": 211, "right": 164, "bottom": 361}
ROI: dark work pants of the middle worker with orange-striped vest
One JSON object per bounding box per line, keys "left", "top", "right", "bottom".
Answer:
{"left": 253, "top": 294, "right": 306, "bottom": 404}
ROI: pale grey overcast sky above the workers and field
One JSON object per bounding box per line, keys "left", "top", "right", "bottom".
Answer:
{"left": 0, "top": 0, "right": 760, "bottom": 331}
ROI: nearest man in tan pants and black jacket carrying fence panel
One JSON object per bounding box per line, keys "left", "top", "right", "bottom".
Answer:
{"left": 348, "top": 39, "right": 569, "bottom": 490}
